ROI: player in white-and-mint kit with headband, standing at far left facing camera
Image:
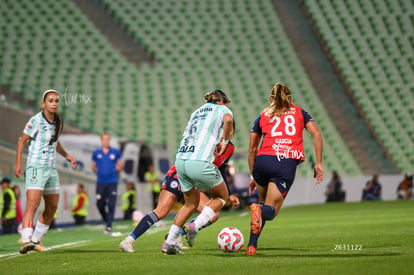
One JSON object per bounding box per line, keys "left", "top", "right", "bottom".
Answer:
{"left": 14, "top": 90, "right": 76, "bottom": 254}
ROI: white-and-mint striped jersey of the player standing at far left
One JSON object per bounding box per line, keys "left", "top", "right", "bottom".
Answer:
{"left": 23, "top": 112, "right": 57, "bottom": 167}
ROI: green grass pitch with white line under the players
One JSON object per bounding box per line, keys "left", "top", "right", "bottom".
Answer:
{"left": 0, "top": 201, "right": 414, "bottom": 274}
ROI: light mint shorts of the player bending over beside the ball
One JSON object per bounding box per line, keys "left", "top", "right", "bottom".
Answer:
{"left": 175, "top": 159, "right": 223, "bottom": 192}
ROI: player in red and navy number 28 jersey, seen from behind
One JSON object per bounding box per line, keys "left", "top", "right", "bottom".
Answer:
{"left": 246, "top": 83, "right": 324, "bottom": 255}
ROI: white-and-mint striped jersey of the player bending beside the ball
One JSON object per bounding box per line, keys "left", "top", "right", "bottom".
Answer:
{"left": 176, "top": 103, "right": 233, "bottom": 162}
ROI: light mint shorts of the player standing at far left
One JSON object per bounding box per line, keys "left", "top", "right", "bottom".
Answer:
{"left": 25, "top": 166, "right": 60, "bottom": 195}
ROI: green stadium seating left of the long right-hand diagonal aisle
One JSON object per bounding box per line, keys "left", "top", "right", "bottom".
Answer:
{"left": 0, "top": 0, "right": 376, "bottom": 176}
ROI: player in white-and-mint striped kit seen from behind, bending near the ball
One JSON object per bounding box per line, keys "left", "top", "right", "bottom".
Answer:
{"left": 162, "top": 90, "right": 233, "bottom": 254}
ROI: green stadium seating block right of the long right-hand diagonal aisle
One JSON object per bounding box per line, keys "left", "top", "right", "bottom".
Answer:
{"left": 304, "top": 0, "right": 414, "bottom": 172}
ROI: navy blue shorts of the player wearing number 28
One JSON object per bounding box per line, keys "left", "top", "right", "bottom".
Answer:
{"left": 253, "top": 155, "right": 299, "bottom": 198}
